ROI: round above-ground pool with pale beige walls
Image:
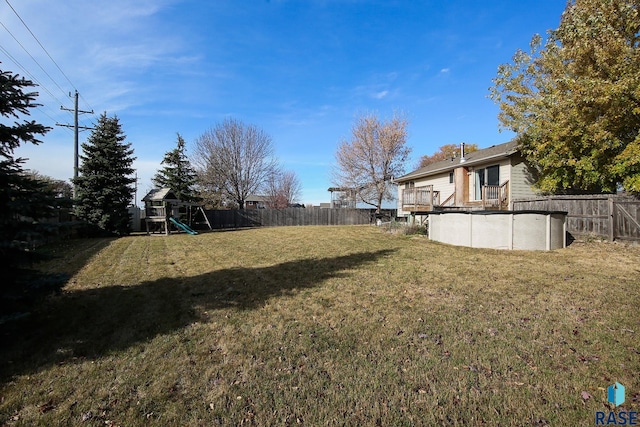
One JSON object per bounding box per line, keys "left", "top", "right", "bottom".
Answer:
{"left": 429, "top": 211, "right": 567, "bottom": 250}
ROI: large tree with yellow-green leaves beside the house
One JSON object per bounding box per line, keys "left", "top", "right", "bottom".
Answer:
{"left": 490, "top": 0, "right": 640, "bottom": 193}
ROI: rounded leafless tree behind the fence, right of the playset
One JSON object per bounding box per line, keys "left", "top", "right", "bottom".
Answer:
{"left": 193, "top": 118, "right": 277, "bottom": 209}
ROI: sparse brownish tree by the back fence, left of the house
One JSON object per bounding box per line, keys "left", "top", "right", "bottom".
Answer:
{"left": 334, "top": 114, "right": 411, "bottom": 212}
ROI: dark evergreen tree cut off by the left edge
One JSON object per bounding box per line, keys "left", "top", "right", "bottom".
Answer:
{"left": 0, "top": 65, "right": 50, "bottom": 281}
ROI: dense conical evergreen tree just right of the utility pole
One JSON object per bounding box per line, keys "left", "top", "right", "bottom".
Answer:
{"left": 74, "top": 113, "right": 136, "bottom": 235}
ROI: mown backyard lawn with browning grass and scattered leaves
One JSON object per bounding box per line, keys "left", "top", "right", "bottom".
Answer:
{"left": 0, "top": 226, "right": 640, "bottom": 426}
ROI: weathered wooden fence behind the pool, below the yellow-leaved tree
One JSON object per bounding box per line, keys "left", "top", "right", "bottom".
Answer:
{"left": 513, "top": 194, "right": 640, "bottom": 241}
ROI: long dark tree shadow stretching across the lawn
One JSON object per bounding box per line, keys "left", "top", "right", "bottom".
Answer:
{"left": 0, "top": 250, "right": 391, "bottom": 383}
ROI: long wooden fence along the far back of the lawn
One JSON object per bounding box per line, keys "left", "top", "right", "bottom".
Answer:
{"left": 205, "top": 208, "right": 396, "bottom": 229}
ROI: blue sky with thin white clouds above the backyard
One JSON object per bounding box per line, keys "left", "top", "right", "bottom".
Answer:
{"left": 0, "top": 0, "right": 566, "bottom": 204}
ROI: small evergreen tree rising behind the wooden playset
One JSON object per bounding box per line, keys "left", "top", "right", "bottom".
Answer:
{"left": 152, "top": 134, "right": 201, "bottom": 202}
